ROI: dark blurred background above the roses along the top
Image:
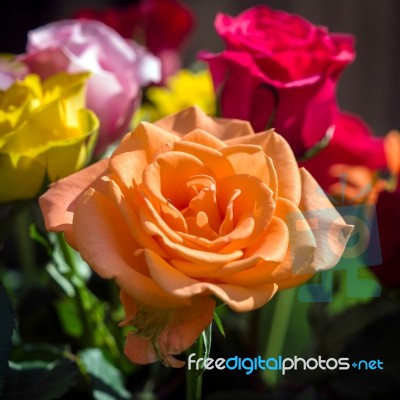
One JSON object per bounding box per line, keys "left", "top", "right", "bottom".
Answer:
{"left": 0, "top": 0, "right": 400, "bottom": 135}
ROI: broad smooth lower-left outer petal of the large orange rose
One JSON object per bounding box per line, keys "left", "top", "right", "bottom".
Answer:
{"left": 73, "top": 189, "right": 185, "bottom": 307}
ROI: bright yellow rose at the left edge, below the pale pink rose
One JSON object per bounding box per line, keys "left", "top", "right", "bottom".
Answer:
{"left": 0, "top": 73, "right": 99, "bottom": 203}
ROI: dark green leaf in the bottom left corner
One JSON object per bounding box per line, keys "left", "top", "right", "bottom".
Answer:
{"left": 3, "top": 358, "right": 79, "bottom": 400}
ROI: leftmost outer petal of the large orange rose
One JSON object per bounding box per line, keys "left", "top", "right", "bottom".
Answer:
{"left": 39, "top": 159, "right": 108, "bottom": 247}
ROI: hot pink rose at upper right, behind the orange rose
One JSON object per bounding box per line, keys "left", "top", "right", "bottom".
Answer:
{"left": 200, "top": 6, "right": 355, "bottom": 155}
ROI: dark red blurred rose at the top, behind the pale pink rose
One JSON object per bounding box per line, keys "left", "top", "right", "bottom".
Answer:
{"left": 74, "top": 0, "right": 193, "bottom": 78}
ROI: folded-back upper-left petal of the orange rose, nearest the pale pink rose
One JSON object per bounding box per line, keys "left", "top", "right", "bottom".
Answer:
{"left": 110, "top": 122, "right": 179, "bottom": 189}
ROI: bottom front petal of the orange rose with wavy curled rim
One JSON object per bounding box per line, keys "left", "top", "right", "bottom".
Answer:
{"left": 145, "top": 250, "right": 277, "bottom": 312}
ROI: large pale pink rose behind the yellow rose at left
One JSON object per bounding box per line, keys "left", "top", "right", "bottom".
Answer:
{"left": 20, "top": 20, "right": 161, "bottom": 153}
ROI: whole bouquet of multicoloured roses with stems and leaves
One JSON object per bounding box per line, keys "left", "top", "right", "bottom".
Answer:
{"left": 0, "top": 0, "right": 400, "bottom": 400}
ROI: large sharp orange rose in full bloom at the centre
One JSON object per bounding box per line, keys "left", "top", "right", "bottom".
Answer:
{"left": 40, "top": 108, "right": 352, "bottom": 366}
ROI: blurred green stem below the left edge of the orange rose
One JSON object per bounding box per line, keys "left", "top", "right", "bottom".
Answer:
{"left": 57, "top": 233, "right": 95, "bottom": 344}
